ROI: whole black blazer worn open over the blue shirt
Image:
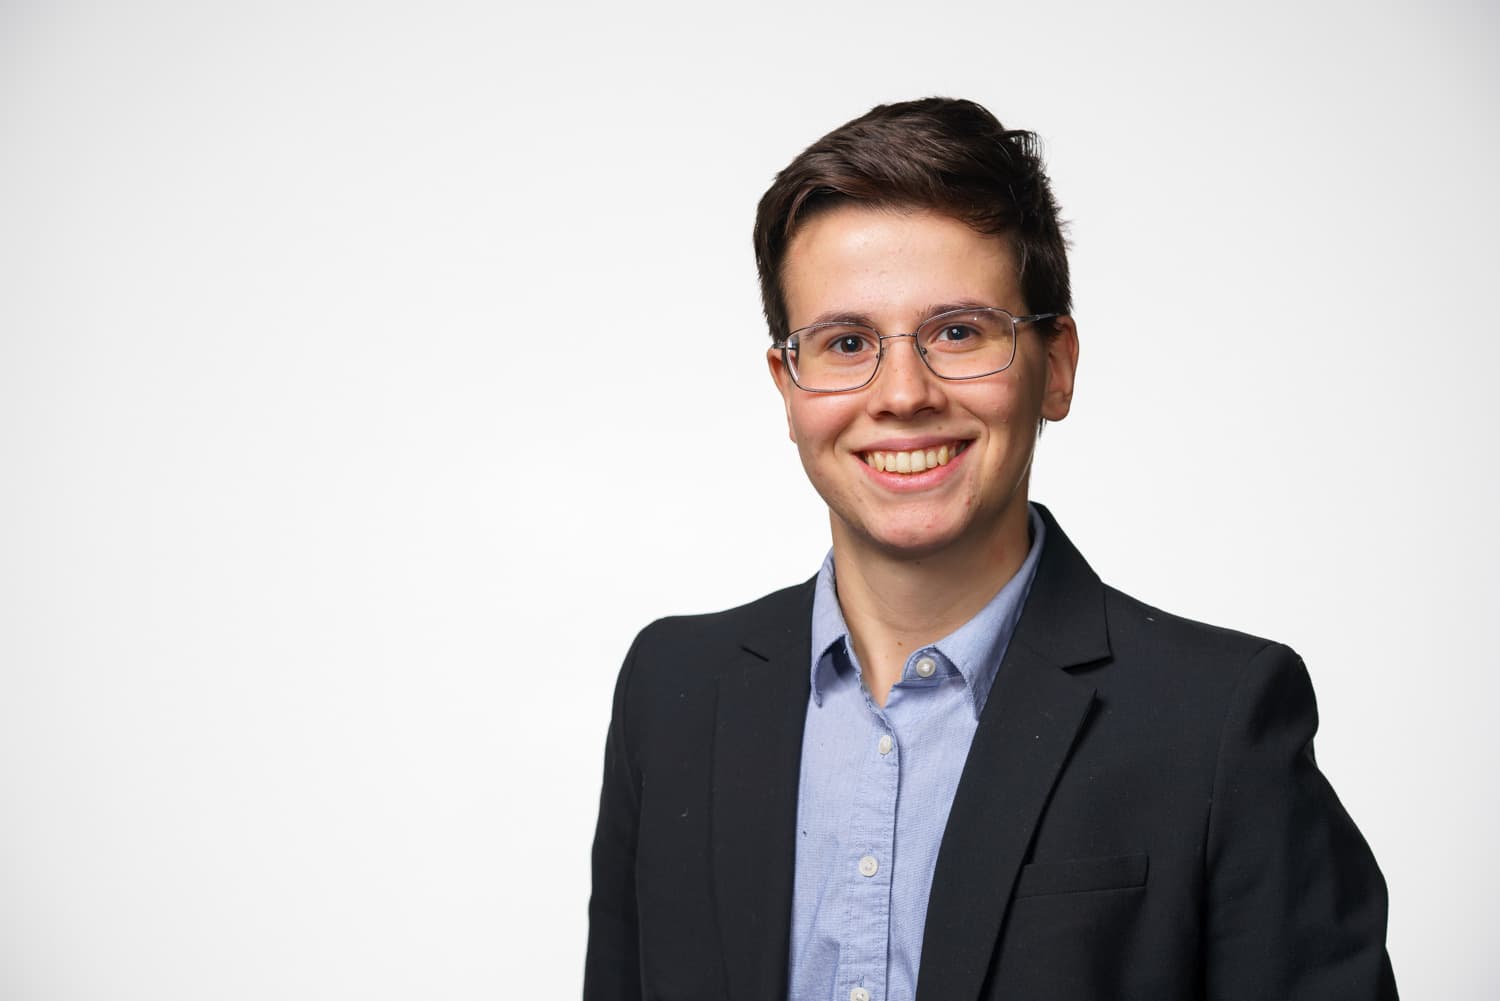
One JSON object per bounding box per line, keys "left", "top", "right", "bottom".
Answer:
{"left": 584, "top": 509, "right": 1397, "bottom": 1001}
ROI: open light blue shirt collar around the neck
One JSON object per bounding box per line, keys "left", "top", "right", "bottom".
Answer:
{"left": 810, "top": 504, "right": 1047, "bottom": 717}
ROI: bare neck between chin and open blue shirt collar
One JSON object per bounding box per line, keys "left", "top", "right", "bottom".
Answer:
{"left": 833, "top": 498, "right": 1031, "bottom": 705}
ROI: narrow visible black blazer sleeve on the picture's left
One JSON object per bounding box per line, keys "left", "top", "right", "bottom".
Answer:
{"left": 584, "top": 638, "right": 641, "bottom": 1001}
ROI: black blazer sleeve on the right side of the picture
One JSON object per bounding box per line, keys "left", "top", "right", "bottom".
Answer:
{"left": 1205, "top": 644, "right": 1397, "bottom": 1001}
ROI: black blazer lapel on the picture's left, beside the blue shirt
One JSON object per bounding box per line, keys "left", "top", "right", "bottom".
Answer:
{"left": 713, "top": 581, "right": 813, "bottom": 1001}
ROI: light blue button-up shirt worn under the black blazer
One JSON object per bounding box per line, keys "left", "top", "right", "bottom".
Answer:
{"left": 791, "top": 509, "right": 1046, "bottom": 1001}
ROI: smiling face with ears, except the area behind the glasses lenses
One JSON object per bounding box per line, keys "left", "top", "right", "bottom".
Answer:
{"left": 767, "top": 206, "right": 1079, "bottom": 558}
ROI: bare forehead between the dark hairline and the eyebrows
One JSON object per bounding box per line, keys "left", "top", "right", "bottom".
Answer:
{"left": 782, "top": 204, "right": 1025, "bottom": 330}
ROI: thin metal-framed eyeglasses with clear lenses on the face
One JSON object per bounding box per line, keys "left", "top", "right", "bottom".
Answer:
{"left": 771, "top": 306, "right": 1062, "bottom": 393}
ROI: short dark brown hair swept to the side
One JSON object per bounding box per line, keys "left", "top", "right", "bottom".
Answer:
{"left": 755, "top": 98, "right": 1073, "bottom": 339}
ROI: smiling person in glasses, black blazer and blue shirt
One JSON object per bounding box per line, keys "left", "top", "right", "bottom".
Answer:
{"left": 584, "top": 99, "right": 1397, "bottom": 1001}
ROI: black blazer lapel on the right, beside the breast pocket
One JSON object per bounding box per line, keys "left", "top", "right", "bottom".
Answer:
{"left": 917, "top": 504, "right": 1110, "bottom": 1001}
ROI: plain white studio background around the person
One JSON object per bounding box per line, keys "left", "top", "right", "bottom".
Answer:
{"left": 0, "top": 0, "right": 1500, "bottom": 1001}
